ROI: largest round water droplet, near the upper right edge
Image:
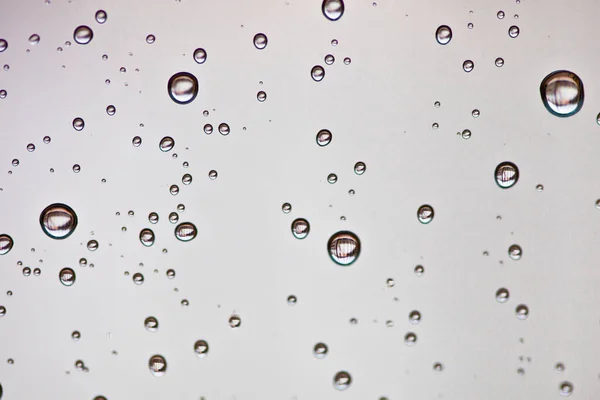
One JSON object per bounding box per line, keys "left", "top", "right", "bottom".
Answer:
{"left": 540, "top": 70, "right": 584, "bottom": 117}
